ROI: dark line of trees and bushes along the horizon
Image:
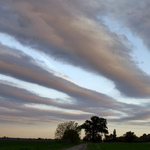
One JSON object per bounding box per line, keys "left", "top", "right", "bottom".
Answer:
{"left": 55, "top": 116, "right": 150, "bottom": 143}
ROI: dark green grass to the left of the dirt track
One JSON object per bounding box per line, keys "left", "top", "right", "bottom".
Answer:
{"left": 0, "top": 140, "right": 77, "bottom": 150}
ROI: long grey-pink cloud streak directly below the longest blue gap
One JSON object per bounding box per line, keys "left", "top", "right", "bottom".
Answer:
{"left": 0, "top": 45, "right": 122, "bottom": 112}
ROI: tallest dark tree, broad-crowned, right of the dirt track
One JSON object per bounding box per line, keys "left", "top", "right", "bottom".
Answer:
{"left": 80, "top": 116, "right": 108, "bottom": 142}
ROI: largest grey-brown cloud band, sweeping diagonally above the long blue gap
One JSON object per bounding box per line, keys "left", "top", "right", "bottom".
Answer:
{"left": 0, "top": 0, "right": 150, "bottom": 98}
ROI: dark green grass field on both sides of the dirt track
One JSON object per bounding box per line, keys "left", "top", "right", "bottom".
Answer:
{"left": 0, "top": 140, "right": 150, "bottom": 150}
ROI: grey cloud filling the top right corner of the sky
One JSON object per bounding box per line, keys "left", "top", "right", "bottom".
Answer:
{"left": 107, "top": 0, "right": 150, "bottom": 50}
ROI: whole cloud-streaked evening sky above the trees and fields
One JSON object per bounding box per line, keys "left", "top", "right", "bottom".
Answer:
{"left": 0, "top": 0, "right": 150, "bottom": 138}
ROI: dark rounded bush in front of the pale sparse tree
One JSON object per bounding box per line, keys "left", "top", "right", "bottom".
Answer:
{"left": 62, "top": 130, "right": 80, "bottom": 144}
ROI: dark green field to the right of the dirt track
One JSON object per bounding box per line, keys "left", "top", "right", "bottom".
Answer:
{"left": 88, "top": 143, "right": 150, "bottom": 150}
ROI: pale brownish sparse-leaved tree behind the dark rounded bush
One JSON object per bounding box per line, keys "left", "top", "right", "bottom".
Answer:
{"left": 55, "top": 121, "right": 80, "bottom": 139}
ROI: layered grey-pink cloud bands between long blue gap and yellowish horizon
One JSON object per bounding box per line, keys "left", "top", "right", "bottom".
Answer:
{"left": 0, "top": 45, "right": 146, "bottom": 122}
